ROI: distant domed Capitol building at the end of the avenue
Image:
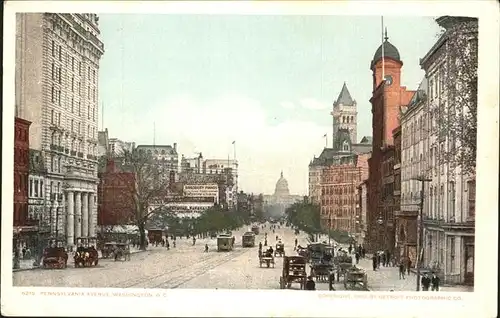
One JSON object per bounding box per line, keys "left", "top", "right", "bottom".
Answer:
{"left": 264, "top": 171, "right": 303, "bottom": 216}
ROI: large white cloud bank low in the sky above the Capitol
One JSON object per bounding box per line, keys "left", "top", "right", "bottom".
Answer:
{"left": 114, "top": 96, "right": 329, "bottom": 194}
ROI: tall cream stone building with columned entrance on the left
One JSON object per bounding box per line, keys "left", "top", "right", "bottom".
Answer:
{"left": 16, "top": 13, "right": 104, "bottom": 246}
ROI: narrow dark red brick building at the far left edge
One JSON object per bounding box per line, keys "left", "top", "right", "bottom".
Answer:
{"left": 13, "top": 117, "right": 35, "bottom": 231}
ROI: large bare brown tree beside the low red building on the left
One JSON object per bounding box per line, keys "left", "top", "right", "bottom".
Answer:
{"left": 121, "top": 149, "right": 169, "bottom": 250}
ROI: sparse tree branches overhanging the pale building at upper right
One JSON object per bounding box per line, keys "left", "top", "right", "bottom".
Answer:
{"left": 437, "top": 17, "right": 478, "bottom": 174}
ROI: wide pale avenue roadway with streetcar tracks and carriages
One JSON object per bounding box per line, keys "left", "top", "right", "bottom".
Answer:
{"left": 13, "top": 222, "right": 470, "bottom": 291}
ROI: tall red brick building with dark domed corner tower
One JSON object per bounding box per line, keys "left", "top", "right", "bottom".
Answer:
{"left": 367, "top": 35, "right": 414, "bottom": 251}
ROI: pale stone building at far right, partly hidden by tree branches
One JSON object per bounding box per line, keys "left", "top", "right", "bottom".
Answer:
{"left": 420, "top": 17, "right": 478, "bottom": 284}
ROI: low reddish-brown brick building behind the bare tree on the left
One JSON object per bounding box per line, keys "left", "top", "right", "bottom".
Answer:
{"left": 97, "top": 159, "right": 135, "bottom": 226}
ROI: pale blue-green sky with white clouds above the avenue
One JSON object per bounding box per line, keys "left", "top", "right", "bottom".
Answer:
{"left": 99, "top": 14, "right": 440, "bottom": 195}
